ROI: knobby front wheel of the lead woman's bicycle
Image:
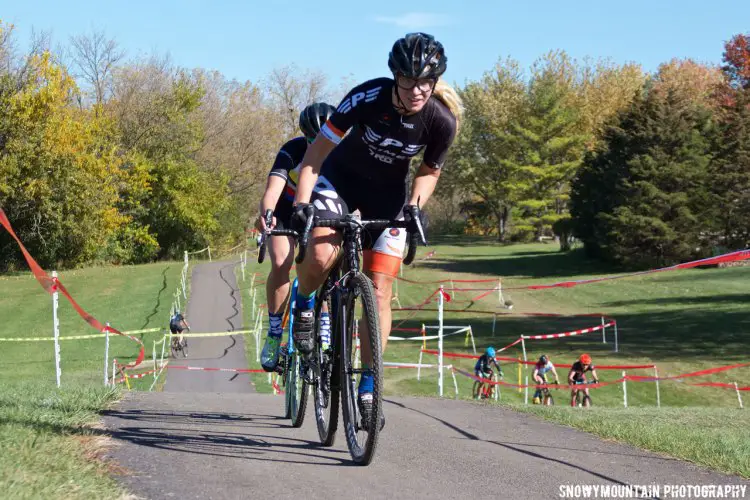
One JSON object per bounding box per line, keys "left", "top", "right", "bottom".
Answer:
{"left": 337, "top": 273, "right": 383, "bottom": 465}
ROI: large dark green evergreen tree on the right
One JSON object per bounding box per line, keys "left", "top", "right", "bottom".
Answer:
{"left": 571, "top": 84, "right": 714, "bottom": 267}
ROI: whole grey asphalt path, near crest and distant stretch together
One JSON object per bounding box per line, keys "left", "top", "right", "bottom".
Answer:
{"left": 104, "top": 263, "right": 750, "bottom": 500}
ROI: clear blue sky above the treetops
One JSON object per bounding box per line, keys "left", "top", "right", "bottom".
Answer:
{"left": 0, "top": 0, "right": 750, "bottom": 90}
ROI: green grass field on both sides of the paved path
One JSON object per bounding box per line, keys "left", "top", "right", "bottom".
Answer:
{"left": 0, "top": 239, "right": 750, "bottom": 492}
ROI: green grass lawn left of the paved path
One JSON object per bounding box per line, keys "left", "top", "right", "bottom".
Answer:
{"left": 0, "top": 262, "right": 182, "bottom": 498}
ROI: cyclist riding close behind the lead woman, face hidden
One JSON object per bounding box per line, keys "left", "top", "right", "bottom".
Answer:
{"left": 256, "top": 102, "right": 336, "bottom": 372}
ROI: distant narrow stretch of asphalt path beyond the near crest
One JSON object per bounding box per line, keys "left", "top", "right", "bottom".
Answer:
{"left": 164, "top": 262, "right": 255, "bottom": 393}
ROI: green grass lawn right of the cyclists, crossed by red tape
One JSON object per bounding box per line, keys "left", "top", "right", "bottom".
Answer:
{"left": 243, "top": 238, "right": 750, "bottom": 475}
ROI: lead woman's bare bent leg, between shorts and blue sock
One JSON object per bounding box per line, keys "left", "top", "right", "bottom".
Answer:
{"left": 297, "top": 227, "right": 341, "bottom": 295}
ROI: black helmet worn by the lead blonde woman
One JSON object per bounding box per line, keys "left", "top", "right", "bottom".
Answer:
{"left": 388, "top": 33, "right": 448, "bottom": 79}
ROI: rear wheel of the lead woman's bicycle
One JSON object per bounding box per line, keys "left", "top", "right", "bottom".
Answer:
{"left": 313, "top": 292, "right": 340, "bottom": 446}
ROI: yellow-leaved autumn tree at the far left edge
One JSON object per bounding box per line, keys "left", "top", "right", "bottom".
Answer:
{"left": 0, "top": 54, "right": 127, "bottom": 267}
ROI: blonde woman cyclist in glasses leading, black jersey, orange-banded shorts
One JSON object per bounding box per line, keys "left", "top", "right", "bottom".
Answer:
{"left": 292, "top": 33, "right": 462, "bottom": 426}
